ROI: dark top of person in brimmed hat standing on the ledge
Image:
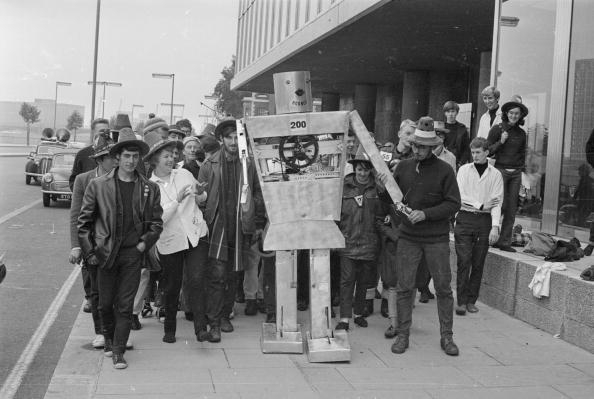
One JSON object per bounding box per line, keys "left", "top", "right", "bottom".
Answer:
{"left": 487, "top": 122, "right": 527, "bottom": 170}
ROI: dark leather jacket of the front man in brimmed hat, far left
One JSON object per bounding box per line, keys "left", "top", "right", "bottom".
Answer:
{"left": 78, "top": 168, "right": 163, "bottom": 269}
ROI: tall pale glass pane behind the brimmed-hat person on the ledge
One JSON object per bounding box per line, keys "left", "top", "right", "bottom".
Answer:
{"left": 496, "top": 0, "right": 552, "bottom": 230}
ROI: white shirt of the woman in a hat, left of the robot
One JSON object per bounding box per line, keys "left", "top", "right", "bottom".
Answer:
{"left": 151, "top": 169, "right": 208, "bottom": 255}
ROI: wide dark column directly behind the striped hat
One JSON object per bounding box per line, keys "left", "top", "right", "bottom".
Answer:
{"left": 402, "top": 71, "right": 429, "bottom": 120}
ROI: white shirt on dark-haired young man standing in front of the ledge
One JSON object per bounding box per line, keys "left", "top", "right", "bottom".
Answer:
{"left": 456, "top": 163, "right": 503, "bottom": 227}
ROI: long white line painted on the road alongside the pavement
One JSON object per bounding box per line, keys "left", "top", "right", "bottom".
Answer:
{"left": 0, "top": 267, "right": 80, "bottom": 399}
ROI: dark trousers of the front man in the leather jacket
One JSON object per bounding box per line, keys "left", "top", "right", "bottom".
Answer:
{"left": 97, "top": 247, "right": 142, "bottom": 354}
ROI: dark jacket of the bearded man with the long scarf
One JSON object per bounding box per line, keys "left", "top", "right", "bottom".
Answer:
{"left": 198, "top": 149, "right": 266, "bottom": 270}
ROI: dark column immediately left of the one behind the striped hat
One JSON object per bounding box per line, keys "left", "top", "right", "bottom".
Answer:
{"left": 374, "top": 84, "right": 402, "bottom": 143}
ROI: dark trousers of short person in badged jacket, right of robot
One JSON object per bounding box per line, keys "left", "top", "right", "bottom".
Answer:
{"left": 340, "top": 256, "right": 375, "bottom": 319}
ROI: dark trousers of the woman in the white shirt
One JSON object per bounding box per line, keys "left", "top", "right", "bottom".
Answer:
{"left": 159, "top": 240, "right": 212, "bottom": 334}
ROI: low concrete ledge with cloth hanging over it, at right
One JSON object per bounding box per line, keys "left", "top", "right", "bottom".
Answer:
{"left": 450, "top": 242, "right": 594, "bottom": 353}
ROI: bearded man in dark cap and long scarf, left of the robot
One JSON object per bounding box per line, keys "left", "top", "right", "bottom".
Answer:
{"left": 198, "top": 117, "right": 266, "bottom": 339}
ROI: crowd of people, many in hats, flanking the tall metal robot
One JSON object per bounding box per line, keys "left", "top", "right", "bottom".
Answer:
{"left": 69, "top": 86, "right": 528, "bottom": 369}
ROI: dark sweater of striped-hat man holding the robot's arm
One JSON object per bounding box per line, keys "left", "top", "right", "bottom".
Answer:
{"left": 390, "top": 154, "right": 460, "bottom": 243}
